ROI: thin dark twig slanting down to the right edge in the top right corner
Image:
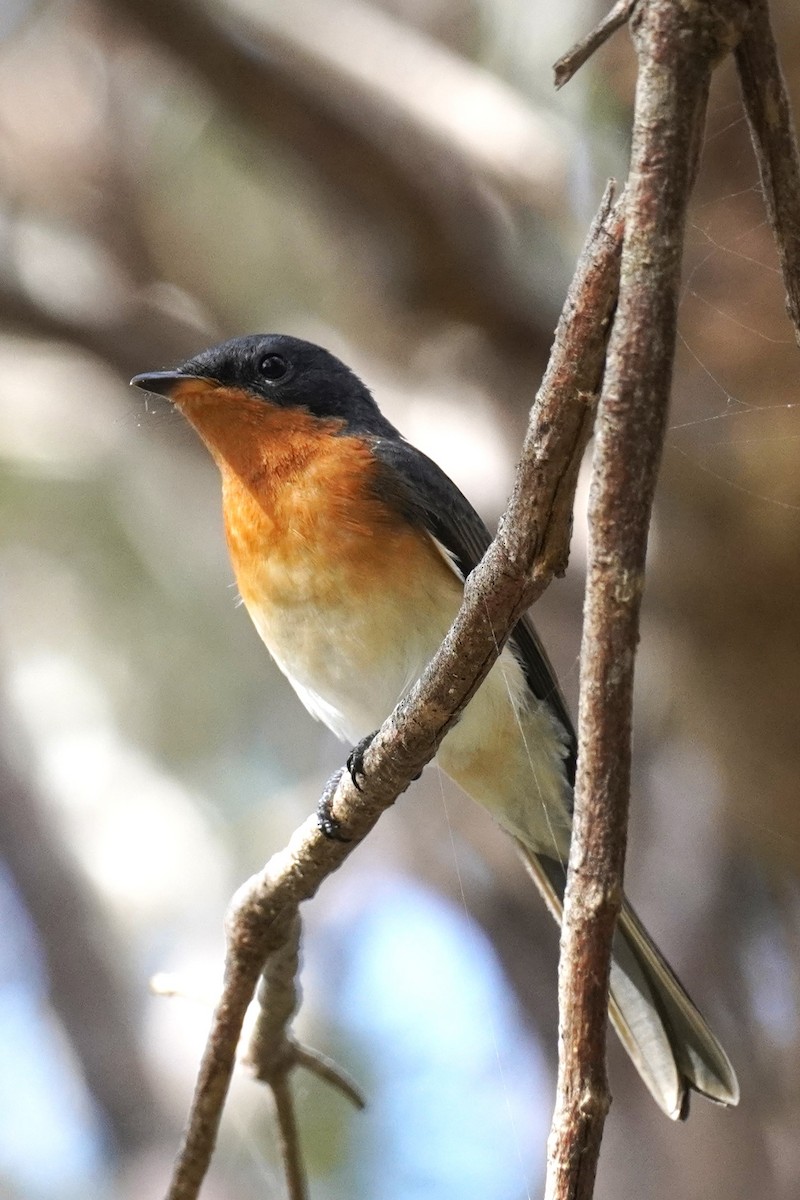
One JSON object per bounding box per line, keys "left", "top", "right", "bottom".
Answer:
{"left": 735, "top": 0, "right": 800, "bottom": 343}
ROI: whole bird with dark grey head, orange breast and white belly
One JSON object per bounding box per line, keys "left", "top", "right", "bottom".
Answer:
{"left": 131, "top": 334, "right": 739, "bottom": 1120}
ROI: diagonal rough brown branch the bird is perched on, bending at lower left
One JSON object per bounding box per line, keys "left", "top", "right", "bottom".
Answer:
{"left": 168, "top": 190, "right": 622, "bottom": 1200}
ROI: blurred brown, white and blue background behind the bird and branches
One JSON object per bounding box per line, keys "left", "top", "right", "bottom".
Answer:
{"left": 0, "top": 0, "right": 800, "bottom": 1200}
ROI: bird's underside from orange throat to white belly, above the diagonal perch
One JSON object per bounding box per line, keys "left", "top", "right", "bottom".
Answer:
{"left": 172, "top": 389, "right": 463, "bottom": 740}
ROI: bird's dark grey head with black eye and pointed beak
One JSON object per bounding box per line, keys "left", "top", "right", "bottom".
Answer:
{"left": 131, "top": 334, "right": 397, "bottom": 437}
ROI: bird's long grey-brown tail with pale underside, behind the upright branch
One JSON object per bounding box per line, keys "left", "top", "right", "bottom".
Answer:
{"left": 519, "top": 842, "right": 739, "bottom": 1121}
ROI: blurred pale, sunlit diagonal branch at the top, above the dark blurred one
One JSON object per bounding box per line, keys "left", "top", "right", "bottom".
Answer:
{"left": 223, "top": 0, "right": 567, "bottom": 216}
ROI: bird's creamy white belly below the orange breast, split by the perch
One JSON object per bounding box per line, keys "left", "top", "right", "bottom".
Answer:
{"left": 241, "top": 556, "right": 570, "bottom": 857}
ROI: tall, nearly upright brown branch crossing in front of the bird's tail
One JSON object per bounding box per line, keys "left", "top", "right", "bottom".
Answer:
{"left": 546, "top": 0, "right": 745, "bottom": 1200}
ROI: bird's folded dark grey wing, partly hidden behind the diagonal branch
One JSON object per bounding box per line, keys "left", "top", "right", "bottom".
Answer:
{"left": 372, "top": 438, "right": 577, "bottom": 782}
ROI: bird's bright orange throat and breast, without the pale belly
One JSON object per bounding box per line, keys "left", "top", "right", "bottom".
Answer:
{"left": 174, "top": 380, "right": 419, "bottom": 601}
